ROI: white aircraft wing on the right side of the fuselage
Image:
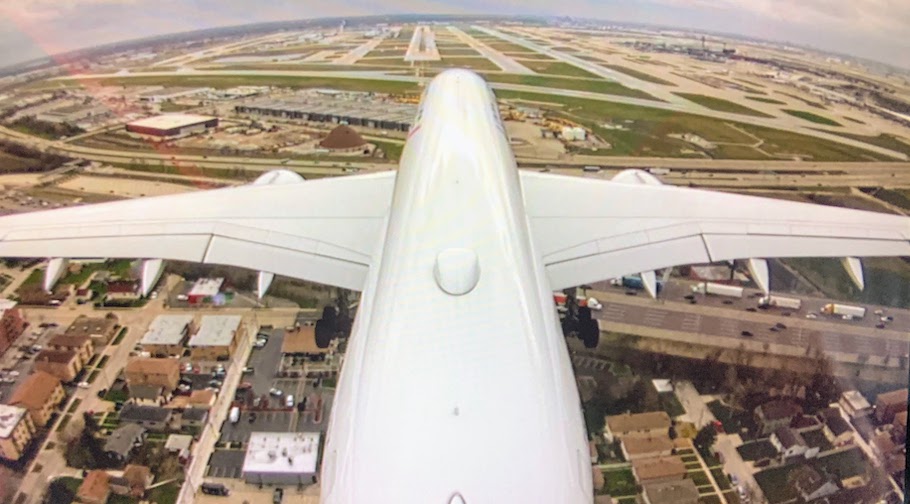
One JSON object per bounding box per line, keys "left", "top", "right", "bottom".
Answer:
{"left": 521, "top": 171, "right": 910, "bottom": 289}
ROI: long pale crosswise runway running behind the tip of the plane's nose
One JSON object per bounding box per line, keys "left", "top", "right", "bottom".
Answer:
{"left": 53, "top": 70, "right": 908, "bottom": 161}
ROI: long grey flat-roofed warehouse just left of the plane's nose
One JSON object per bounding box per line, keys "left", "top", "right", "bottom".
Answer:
{"left": 234, "top": 97, "right": 417, "bottom": 131}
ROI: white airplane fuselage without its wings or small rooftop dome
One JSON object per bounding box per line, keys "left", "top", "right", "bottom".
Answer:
{"left": 321, "top": 70, "right": 593, "bottom": 504}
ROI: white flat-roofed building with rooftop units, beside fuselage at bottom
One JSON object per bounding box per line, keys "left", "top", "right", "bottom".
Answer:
{"left": 243, "top": 432, "right": 320, "bottom": 485}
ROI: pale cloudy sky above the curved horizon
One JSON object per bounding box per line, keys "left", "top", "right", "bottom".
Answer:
{"left": 0, "top": 0, "right": 910, "bottom": 68}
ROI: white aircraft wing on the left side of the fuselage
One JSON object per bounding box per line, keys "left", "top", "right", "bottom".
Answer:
{"left": 0, "top": 172, "right": 395, "bottom": 290}
